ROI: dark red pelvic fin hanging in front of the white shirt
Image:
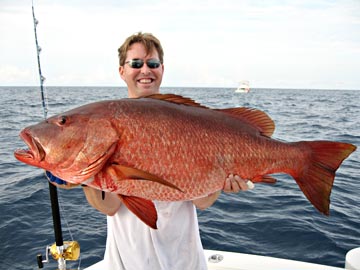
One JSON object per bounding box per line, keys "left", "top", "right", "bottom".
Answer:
{"left": 118, "top": 195, "right": 157, "bottom": 230}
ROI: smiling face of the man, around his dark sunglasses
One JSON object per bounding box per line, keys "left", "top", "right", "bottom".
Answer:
{"left": 119, "top": 43, "right": 164, "bottom": 98}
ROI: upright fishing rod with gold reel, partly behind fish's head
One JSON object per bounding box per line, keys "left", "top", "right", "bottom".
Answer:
{"left": 32, "top": 1, "right": 80, "bottom": 270}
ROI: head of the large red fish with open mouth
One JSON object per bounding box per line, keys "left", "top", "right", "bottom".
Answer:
{"left": 14, "top": 104, "right": 120, "bottom": 184}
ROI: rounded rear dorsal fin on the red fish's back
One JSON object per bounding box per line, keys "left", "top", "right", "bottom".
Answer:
{"left": 217, "top": 107, "right": 275, "bottom": 137}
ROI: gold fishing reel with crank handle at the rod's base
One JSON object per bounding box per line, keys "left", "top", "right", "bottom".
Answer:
{"left": 37, "top": 241, "right": 80, "bottom": 269}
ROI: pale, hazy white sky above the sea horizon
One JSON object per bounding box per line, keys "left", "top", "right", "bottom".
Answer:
{"left": 0, "top": 0, "right": 360, "bottom": 90}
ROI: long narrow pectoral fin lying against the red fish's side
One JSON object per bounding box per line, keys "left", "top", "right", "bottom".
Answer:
{"left": 111, "top": 164, "right": 183, "bottom": 192}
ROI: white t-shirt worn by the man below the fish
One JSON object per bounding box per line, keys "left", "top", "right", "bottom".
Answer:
{"left": 104, "top": 201, "right": 207, "bottom": 270}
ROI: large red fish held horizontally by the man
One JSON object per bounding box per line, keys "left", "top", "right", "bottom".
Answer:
{"left": 15, "top": 94, "right": 356, "bottom": 228}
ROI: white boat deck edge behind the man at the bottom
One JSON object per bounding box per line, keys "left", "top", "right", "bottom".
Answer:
{"left": 85, "top": 247, "right": 360, "bottom": 270}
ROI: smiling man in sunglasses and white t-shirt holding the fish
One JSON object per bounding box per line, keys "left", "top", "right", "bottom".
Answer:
{"left": 50, "top": 33, "right": 252, "bottom": 270}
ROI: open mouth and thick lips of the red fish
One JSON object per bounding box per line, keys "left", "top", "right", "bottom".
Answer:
{"left": 14, "top": 130, "right": 46, "bottom": 163}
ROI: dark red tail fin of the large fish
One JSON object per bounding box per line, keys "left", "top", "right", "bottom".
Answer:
{"left": 292, "top": 141, "right": 356, "bottom": 215}
